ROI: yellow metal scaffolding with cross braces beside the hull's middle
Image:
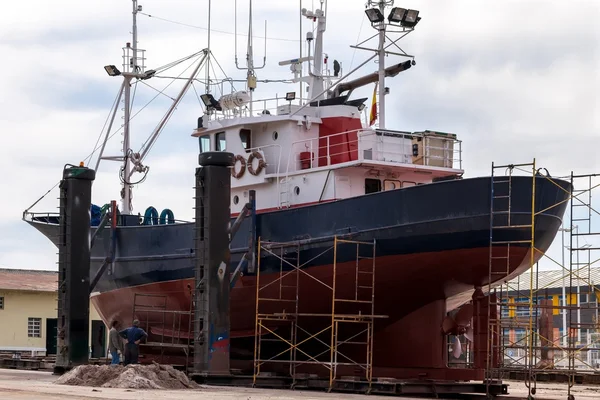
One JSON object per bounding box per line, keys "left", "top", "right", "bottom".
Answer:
{"left": 253, "top": 236, "right": 384, "bottom": 390}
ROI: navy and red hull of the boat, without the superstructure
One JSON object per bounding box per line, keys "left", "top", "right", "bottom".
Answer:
{"left": 27, "top": 177, "right": 571, "bottom": 374}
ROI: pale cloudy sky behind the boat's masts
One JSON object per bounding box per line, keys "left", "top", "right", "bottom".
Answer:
{"left": 0, "top": 0, "right": 600, "bottom": 276}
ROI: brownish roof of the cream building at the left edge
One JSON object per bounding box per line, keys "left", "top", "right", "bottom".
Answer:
{"left": 0, "top": 268, "right": 58, "bottom": 292}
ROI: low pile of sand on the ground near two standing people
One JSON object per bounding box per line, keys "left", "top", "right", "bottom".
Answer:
{"left": 55, "top": 363, "right": 200, "bottom": 389}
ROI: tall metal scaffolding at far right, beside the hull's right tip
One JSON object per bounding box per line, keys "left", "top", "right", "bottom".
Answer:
{"left": 487, "top": 160, "right": 600, "bottom": 399}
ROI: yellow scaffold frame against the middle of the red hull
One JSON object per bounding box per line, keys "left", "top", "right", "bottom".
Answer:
{"left": 253, "top": 236, "right": 386, "bottom": 390}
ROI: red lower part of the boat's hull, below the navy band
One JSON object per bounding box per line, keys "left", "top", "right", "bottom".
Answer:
{"left": 92, "top": 248, "right": 529, "bottom": 380}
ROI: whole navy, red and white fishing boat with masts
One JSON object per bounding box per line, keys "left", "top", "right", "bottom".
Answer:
{"left": 24, "top": 0, "right": 571, "bottom": 377}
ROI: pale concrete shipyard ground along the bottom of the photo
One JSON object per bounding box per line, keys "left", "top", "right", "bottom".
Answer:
{"left": 0, "top": 369, "right": 600, "bottom": 400}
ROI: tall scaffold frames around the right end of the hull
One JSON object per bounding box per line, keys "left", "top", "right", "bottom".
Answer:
{"left": 486, "top": 159, "right": 600, "bottom": 398}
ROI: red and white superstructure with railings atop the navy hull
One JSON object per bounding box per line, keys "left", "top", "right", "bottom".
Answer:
{"left": 192, "top": 2, "right": 463, "bottom": 215}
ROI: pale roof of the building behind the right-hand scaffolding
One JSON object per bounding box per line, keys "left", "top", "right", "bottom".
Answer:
{"left": 508, "top": 266, "right": 600, "bottom": 291}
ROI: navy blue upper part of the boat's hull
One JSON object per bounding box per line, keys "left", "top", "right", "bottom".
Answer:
{"left": 33, "top": 177, "right": 570, "bottom": 300}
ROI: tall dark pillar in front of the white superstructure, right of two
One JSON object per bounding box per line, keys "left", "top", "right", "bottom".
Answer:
{"left": 193, "top": 152, "right": 234, "bottom": 377}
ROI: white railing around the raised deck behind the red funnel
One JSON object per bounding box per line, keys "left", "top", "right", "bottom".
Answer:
{"left": 287, "top": 129, "right": 462, "bottom": 173}
